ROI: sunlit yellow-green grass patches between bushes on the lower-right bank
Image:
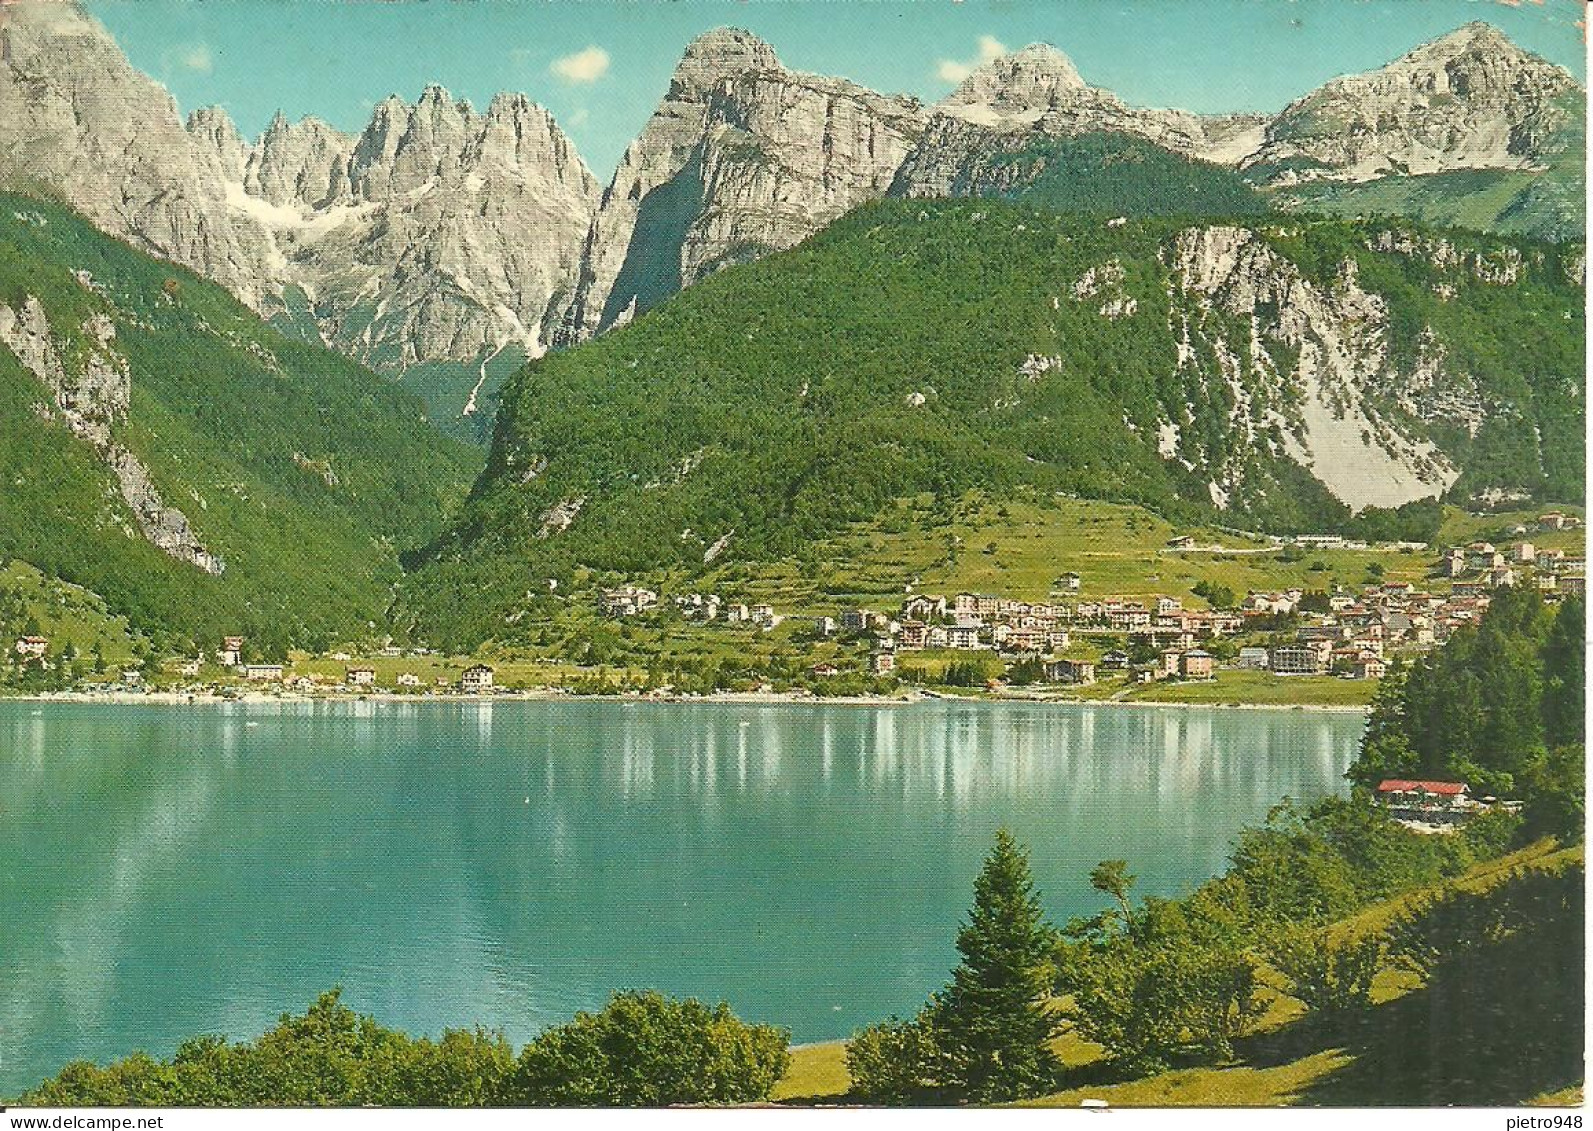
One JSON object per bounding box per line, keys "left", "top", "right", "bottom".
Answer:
{"left": 774, "top": 841, "right": 1585, "bottom": 1107}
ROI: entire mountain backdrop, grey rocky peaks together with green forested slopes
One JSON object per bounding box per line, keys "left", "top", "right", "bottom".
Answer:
{"left": 0, "top": 0, "right": 1585, "bottom": 652}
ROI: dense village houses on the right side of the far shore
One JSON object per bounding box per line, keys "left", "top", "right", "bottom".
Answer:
{"left": 599, "top": 511, "right": 1587, "bottom": 687}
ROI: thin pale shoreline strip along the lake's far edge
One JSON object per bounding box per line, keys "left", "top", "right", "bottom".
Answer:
{"left": 0, "top": 688, "right": 1372, "bottom": 715}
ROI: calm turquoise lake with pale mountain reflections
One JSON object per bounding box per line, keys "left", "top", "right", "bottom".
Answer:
{"left": 0, "top": 701, "right": 1362, "bottom": 1094}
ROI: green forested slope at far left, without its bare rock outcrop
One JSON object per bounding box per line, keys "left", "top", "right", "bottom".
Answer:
{"left": 0, "top": 196, "right": 472, "bottom": 640}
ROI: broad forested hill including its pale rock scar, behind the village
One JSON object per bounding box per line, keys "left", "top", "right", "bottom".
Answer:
{"left": 408, "top": 201, "right": 1583, "bottom": 649}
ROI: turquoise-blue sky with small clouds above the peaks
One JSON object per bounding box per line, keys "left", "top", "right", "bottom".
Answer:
{"left": 84, "top": 0, "right": 1587, "bottom": 180}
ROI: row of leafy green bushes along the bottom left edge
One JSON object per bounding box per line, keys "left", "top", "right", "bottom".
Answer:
{"left": 22, "top": 989, "right": 789, "bottom": 1107}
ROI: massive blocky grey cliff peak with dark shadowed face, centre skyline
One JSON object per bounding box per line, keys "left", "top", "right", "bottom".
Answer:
{"left": 564, "top": 29, "right": 924, "bottom": 339}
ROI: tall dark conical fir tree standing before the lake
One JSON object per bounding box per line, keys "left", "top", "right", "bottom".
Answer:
{"left": 932, "top": 830, "right": 1059, "bottom": 1102}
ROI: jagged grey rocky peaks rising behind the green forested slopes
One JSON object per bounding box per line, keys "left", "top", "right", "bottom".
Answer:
{"left": 0, "top": 0, "right": 1585, "bottom": 438}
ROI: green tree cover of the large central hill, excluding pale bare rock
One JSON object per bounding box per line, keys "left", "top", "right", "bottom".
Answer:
{"left": 408, "top": 201, "right": 1582, "bottom": 644}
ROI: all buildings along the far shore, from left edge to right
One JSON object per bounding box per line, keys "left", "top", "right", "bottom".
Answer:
{"left": 8, "top": 511, "right": 1587, "bottom": 702}
